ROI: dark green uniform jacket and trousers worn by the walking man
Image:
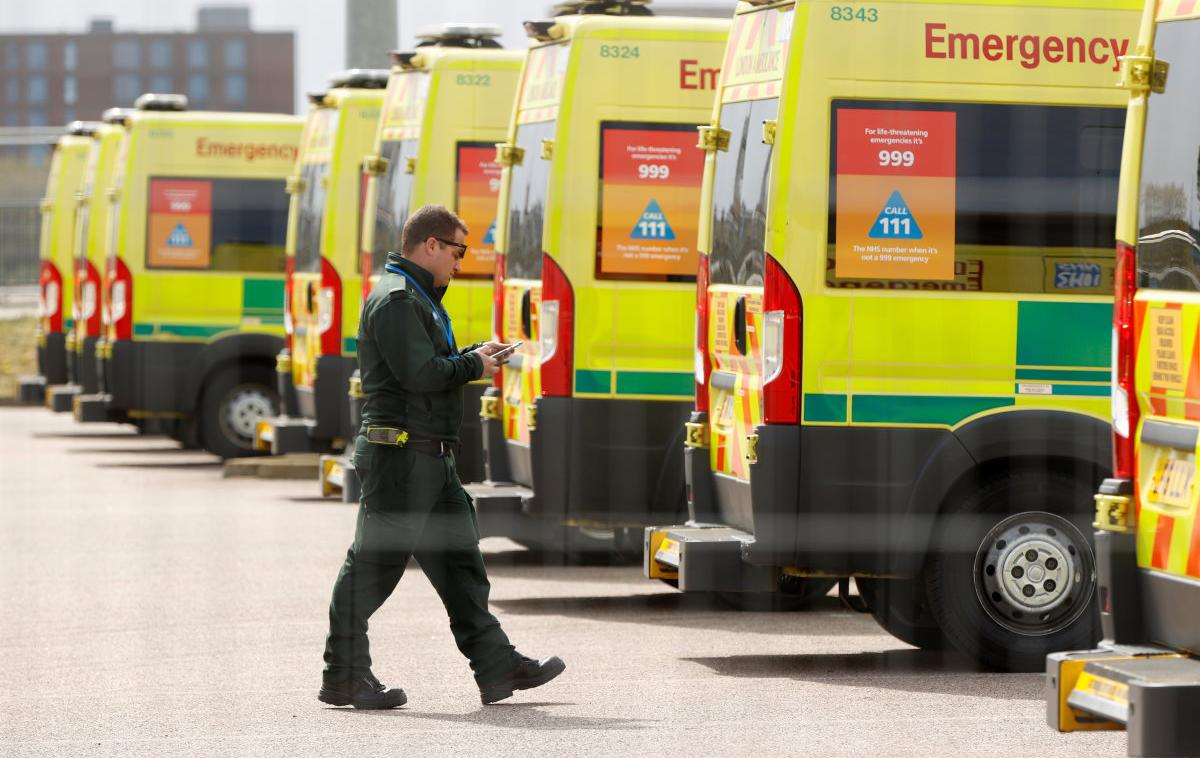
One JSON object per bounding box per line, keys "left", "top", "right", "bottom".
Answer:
{"left": 325, "top": 253, "right": 521, "bottom": 682}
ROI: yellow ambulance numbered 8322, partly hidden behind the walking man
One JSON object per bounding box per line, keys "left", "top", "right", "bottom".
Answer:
{"left": 320, "top": 24, "right": 524, "bottom": 503}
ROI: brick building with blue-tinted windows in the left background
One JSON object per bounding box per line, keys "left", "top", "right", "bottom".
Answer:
{"left": 0, "top": 6, "right": 295, "bottom": 127}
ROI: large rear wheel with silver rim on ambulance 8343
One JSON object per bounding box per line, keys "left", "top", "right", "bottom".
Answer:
{"left": 926, "top": 470, "right": 1099, "bottom": 672}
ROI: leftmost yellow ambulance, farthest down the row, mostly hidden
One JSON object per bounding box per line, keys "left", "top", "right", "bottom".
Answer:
{"left": 19, "top": 121, "right": 95, "bottom": 404}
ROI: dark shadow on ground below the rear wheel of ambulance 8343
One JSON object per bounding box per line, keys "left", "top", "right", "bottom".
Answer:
{"left": 682, "top": 648, "right": 1045, "bottom": 700}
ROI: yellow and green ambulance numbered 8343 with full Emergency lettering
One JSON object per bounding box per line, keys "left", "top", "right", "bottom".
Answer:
{"left": 644, "top": 0, "right": 1140, "bottom": 670}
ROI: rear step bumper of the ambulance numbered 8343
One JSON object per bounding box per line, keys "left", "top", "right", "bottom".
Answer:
{"left": 642, "top": 524, "right": 779, "bottom": 592}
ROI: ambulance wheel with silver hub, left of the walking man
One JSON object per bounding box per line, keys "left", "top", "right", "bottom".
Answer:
{"left": 199, "top": 365, "right": 280, "bottom": 458}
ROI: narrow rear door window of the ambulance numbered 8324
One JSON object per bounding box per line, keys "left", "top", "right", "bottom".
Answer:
{"left": 505, "top": 121, "right": 554, "bottom": 279}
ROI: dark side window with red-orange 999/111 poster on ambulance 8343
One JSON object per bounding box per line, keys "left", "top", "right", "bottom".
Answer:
{"left": 826, "top": 100, "right": 1124, "bottom": 295}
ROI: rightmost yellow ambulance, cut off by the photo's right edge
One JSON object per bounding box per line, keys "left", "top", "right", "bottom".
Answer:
{"left": 1046, "top": 0, "right": 1200, "bottom": 756}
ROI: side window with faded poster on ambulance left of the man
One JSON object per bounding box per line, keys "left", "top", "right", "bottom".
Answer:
{"left": 146, "top": 176, "right": 288, "bottom": 273}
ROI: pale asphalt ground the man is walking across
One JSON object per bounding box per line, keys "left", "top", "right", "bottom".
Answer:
{"left": 0, "top": 408, "right": 1124, "bottom": 758}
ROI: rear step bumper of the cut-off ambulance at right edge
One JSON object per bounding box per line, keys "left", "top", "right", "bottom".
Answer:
{"left": 1046, "top": 645, "right": 1200, "bottom": 756}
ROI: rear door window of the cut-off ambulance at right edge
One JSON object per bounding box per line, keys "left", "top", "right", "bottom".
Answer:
{"left": 1138, "top": 19, "right": 1200, "bottom": 291}
